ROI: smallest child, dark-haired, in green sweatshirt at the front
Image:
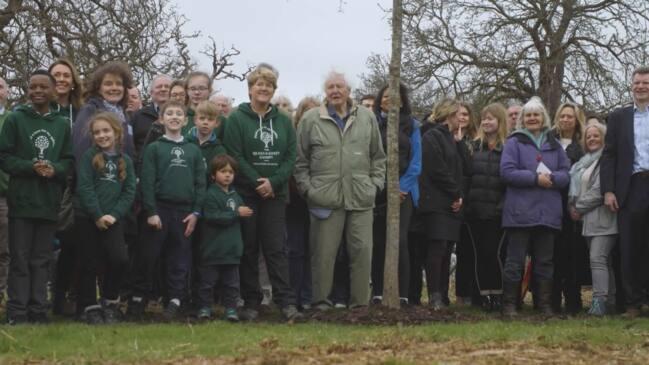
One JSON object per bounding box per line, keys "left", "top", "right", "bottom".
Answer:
{"left": 198, "top": 155, "right": 253, "bottom": 322}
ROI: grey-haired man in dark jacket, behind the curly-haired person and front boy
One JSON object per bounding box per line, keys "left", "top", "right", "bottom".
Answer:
{"left": 131, "top": 75, "right": 172, "bottom": 156}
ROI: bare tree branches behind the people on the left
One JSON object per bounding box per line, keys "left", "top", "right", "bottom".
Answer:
{"left": 0, "top": 0, "right": 248, "bottom": 102}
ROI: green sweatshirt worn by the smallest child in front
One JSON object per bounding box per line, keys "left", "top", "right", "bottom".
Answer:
{"left": 200, "top": 184, "right": 243, "bottom": 265}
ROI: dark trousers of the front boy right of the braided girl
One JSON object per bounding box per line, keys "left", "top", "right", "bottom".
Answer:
{"left": 133, "top": 202, "right": 192, "bottom": 300}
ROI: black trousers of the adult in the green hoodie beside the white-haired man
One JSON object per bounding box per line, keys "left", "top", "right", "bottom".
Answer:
{"left": 239, "top": 197, "right": 295, "bottom": 308}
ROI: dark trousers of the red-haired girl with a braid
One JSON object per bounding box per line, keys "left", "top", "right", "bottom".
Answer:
{"left": 75, "top": 217, "right": 128, "bottom": 313}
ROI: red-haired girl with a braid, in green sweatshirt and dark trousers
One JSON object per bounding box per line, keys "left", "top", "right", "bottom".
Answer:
{"left": 75, "top": 112, "right": 135, "bottom": 324}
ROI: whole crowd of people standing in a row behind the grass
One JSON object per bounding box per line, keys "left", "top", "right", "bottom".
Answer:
{"left": 0, "top": 59, "right": 649, "bottom": 324}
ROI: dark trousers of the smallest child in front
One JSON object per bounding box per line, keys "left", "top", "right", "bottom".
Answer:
{"left": 197, "top": 265, "right": 239, "bottom": 308}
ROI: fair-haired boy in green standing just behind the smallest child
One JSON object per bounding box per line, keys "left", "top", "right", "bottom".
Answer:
{"left": 187, "top": 100, "right": 225, "bottom": 183}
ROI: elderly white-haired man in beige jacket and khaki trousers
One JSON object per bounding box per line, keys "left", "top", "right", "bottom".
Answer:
{"left": 295, "top": 72, "right": 386, "bottom": 310}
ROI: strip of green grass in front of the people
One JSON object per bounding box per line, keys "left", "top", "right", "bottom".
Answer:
{"left": 0, "top": 317, "right": 649, "bottom": 363}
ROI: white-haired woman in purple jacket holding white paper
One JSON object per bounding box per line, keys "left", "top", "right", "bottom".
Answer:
{"left": 500, "top": 97, "right": 570, "bottom": 316}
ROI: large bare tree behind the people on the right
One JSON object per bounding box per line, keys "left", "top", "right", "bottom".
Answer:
{"left": 360, "top": 0, "right": 649, "bottom": 111}
